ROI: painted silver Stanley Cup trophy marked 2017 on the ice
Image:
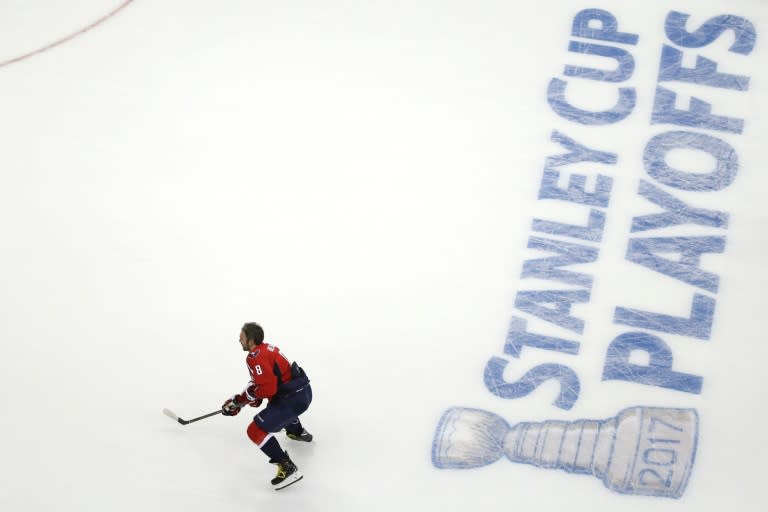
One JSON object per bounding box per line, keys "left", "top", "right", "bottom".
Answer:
{"left": 432, "top": 407, "right": 698, "bottom": 498}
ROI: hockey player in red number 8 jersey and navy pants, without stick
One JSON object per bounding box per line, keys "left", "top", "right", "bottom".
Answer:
{"left": 221, "top": 322, "right": 312, "bottom": 490}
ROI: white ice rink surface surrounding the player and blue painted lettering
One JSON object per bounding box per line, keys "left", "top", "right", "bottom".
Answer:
{"left": 0, "top": 0, "right": 768, "bottom": 512}
